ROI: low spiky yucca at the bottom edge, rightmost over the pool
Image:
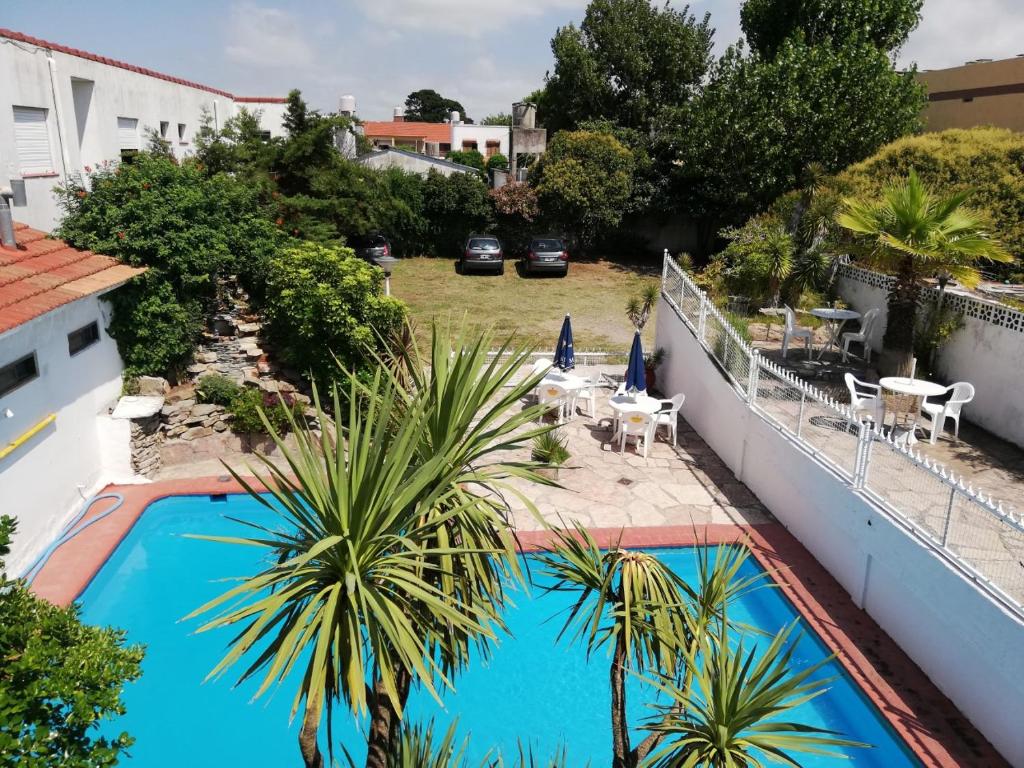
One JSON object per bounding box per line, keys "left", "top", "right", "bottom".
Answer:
{"left": 642, "top": 621, "right": 868, "bottom": 768}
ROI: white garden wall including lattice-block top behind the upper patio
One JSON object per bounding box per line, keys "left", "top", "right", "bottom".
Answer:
{"left": 837, "top": 266, "right": 1024, "bottom": 446}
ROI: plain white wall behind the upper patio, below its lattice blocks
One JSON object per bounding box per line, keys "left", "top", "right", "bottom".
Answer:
{"left": 837, "top": 275, "right": 1024, "bottom": 448}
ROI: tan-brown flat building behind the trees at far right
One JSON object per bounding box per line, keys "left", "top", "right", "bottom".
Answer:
{"left": 918, "top": 54, "right": 1024, "bottom": 131}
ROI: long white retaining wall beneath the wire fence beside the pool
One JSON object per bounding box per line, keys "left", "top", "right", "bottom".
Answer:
{"left": 655, "top": 292, "right": 1024, "bottom": 766}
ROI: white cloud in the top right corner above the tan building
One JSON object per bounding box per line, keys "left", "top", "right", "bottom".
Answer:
{"left": 899, "top": 0, "right": 1024, "bottom": 70}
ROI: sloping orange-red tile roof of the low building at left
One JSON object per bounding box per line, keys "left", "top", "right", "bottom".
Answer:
{"left": 0, "top": 223, "right": 145, "bottom": 334}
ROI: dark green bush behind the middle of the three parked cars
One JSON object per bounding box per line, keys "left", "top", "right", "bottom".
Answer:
{"left": 423, "top": 170, "right": 492, "bottom": 256}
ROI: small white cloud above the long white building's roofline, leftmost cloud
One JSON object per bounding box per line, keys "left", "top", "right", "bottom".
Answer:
{"left": 224, "top": 3, "right": 315, "bottom": 70}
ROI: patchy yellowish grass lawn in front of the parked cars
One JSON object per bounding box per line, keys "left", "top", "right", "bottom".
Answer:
{"left": 391, "top": 258, "right": 660, "bottom": 352}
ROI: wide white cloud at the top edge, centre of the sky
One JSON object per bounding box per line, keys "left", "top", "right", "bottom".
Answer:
{"left": 360, "top": 0, "right": 587, "bottom": 37}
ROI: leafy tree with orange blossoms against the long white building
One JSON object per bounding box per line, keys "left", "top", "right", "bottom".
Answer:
{"left": 57, "top": 152, "right": 283, "bottom": 375}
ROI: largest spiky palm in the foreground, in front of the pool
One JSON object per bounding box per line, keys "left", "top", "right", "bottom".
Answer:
{"left": 184, "top": 328, "right": 548, "bottom": 768}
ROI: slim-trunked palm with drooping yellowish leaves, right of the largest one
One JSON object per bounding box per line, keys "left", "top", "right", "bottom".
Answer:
{"left": 540, "top": 523, "right": 760, "bottom": 768}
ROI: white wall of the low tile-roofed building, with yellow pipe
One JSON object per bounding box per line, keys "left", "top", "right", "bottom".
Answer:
{"left": 0, "top": 296, "right": 132, "bottom": 573}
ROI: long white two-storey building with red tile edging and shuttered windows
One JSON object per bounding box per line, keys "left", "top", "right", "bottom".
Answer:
{"left": 0, "top": 29, "right": 286, "bottom": 231}
